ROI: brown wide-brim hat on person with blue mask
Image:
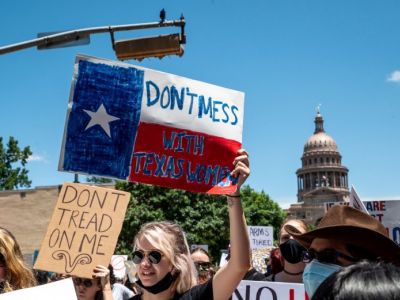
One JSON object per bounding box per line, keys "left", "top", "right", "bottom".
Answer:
{"left": 285, "top": 205, "right": 400, "bottom": 263}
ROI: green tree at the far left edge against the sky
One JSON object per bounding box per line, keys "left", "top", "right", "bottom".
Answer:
{"left": 0, "top": 136, "right": 32, "bottom": 190}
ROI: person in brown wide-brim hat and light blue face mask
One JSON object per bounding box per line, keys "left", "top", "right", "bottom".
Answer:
{"left": 285, "top": 205, "right": 400, "bottom": 298}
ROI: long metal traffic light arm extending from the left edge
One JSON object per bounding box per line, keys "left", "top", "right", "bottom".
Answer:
{"left": 0, "top": 18, "right": 185, "bottom": 55}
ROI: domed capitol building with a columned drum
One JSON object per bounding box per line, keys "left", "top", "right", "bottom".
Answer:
{"left": 286, "top": 111, "right": 349, "bottom": 224}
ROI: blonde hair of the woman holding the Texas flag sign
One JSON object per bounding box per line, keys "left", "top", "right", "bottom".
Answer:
{"left": 134, "top": 221, "right": 197, "bottom": 294}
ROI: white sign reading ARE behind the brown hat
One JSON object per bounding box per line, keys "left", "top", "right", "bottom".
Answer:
{"left": 364, "top": 200, "right": 400, "bottom": 246}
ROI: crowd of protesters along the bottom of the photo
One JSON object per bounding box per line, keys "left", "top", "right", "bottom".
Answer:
{"left": 0, "top": 150, "right": 400, "bottom": 300}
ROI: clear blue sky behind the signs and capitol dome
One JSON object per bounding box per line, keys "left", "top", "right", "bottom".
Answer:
{"left": 0, "top": 0, "right": 400, "bottom": 207}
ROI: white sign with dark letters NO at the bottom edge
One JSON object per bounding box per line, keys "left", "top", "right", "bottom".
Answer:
{"left": 232, "top": 280, "right": 309, "bottom": 300}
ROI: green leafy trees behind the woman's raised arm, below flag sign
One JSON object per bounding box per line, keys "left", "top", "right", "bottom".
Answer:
{"left": 116, "top": 182, "right": 283, "bottom": 259}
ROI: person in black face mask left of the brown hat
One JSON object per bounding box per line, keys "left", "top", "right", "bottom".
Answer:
{"left": 268, "top": 220, "right": 308, "bottom": 283}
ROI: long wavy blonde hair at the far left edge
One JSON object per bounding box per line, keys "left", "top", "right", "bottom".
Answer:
{"left": 0, "top": 227, "right": 36, "bottom": 292}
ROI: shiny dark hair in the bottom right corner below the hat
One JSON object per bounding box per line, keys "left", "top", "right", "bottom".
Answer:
{"left": 311, "top": 260, "right": 400, "bottom": 300}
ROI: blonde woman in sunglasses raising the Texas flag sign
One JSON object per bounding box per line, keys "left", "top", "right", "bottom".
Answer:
{"left": 131, "top": 150, "right": 250, "bottom": 300}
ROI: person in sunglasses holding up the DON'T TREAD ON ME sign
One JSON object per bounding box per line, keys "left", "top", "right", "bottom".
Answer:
{"left": 72, "top": 265, "right": 113, "bottom": 300}
